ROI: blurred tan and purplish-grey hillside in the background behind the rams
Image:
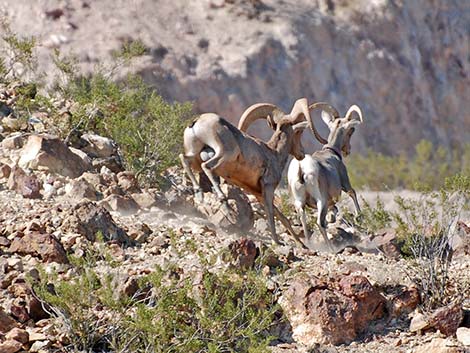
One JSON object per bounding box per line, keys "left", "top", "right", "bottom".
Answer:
{"left": 0, "top": 0, "right": 470, "bottom": 153}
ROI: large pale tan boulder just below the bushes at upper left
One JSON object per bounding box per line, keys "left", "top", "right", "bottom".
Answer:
{"left": 18, "top": 135, "right": 91, "bottom": 178}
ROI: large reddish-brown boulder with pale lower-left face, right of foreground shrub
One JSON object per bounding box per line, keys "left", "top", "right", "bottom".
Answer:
{"left": 280, "top": 276, "right": 386, "bottom": 347}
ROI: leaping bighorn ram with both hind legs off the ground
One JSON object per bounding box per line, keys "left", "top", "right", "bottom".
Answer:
{"left": 180, "top": 98, "right": 312, "bottom": 245}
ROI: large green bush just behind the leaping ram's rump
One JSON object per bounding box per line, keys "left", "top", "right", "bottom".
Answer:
{"left": 54, "top": 48, "right": 191, "bottom": 184}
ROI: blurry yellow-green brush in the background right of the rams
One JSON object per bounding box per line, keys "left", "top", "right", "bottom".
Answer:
{"left": 346, "top": 140, "right": 470, "bottom": 190}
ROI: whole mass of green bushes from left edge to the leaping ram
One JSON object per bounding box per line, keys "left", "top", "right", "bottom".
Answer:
{"left": 0, "top": 23, "right": 191, "bottom": 184}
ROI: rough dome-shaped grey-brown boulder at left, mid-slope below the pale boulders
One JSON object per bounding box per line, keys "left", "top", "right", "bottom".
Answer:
{"left": 61, "top": 201, "right": 131, "bottom": 244}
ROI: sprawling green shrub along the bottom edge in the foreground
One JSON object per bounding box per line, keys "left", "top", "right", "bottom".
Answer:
{"left": 34, "top": 250, "right": 280, "bottom": 353}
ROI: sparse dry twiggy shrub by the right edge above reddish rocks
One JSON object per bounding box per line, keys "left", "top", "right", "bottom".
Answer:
{"left": 393, "top": 175, "right": 470, "bottom": 309}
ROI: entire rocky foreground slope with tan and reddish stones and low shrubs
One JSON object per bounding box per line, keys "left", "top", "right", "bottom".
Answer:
{"left": 0, "top": 83, "right": 470, "bottom": 353}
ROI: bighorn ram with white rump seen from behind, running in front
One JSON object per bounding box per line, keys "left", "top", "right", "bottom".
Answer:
{"left": 287, "top": 103, "right": 363, "bottom": 244}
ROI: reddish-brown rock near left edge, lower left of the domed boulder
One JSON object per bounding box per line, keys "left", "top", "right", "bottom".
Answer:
{"left": 10, "top": 232, "right": 68, "bottom": 263}
